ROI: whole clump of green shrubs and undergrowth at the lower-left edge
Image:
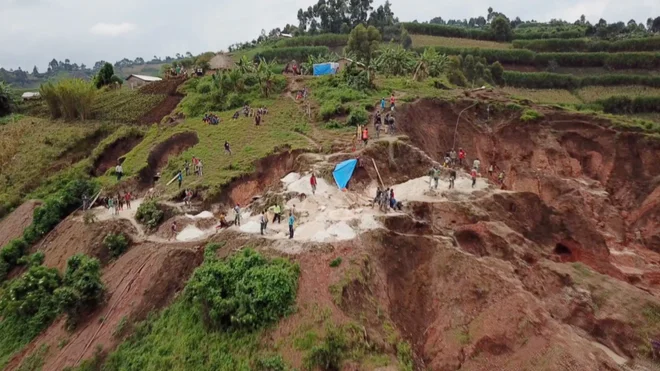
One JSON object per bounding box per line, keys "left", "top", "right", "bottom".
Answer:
{"left": 0, "top": 255, "right": 104, "bottom": 367}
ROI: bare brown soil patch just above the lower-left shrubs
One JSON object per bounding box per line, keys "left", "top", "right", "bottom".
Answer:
{"left": 37, "top": 216, "right": 137, "bottom": 271}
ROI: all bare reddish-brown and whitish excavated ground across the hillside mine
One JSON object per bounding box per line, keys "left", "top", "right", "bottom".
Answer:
{"left": 7, "top": 100, "right": 660, "bottom": 371}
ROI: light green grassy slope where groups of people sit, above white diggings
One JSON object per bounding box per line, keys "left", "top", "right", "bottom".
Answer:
{"left": 111, "top": 99, "right": 312, "bottom": 199}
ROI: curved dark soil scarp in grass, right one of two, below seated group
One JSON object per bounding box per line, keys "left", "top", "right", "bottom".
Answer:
{"left": 139, "top": 132, "right": 199, "bottom": 187}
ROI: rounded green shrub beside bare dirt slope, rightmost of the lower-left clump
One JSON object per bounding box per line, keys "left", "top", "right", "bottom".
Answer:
{"left": 54, "top": 254, "right": 105, "bottom": 327}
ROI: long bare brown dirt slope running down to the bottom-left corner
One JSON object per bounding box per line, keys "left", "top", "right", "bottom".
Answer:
{"left": 6, "top": 243, "right": 202, "bottom": 370}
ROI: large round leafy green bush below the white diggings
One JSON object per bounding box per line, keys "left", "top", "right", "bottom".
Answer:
{"left": 186, "top": 249, "right": 299, "bottom": 331}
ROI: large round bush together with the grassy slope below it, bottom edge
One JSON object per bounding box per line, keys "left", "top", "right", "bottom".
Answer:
{"left": 103, "top": 246, "right": 298, "bottom": 371}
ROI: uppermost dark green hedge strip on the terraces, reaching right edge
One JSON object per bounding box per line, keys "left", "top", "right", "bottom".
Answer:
{"left": 513, "top": 37, "right": 660, "bottom": 53}
